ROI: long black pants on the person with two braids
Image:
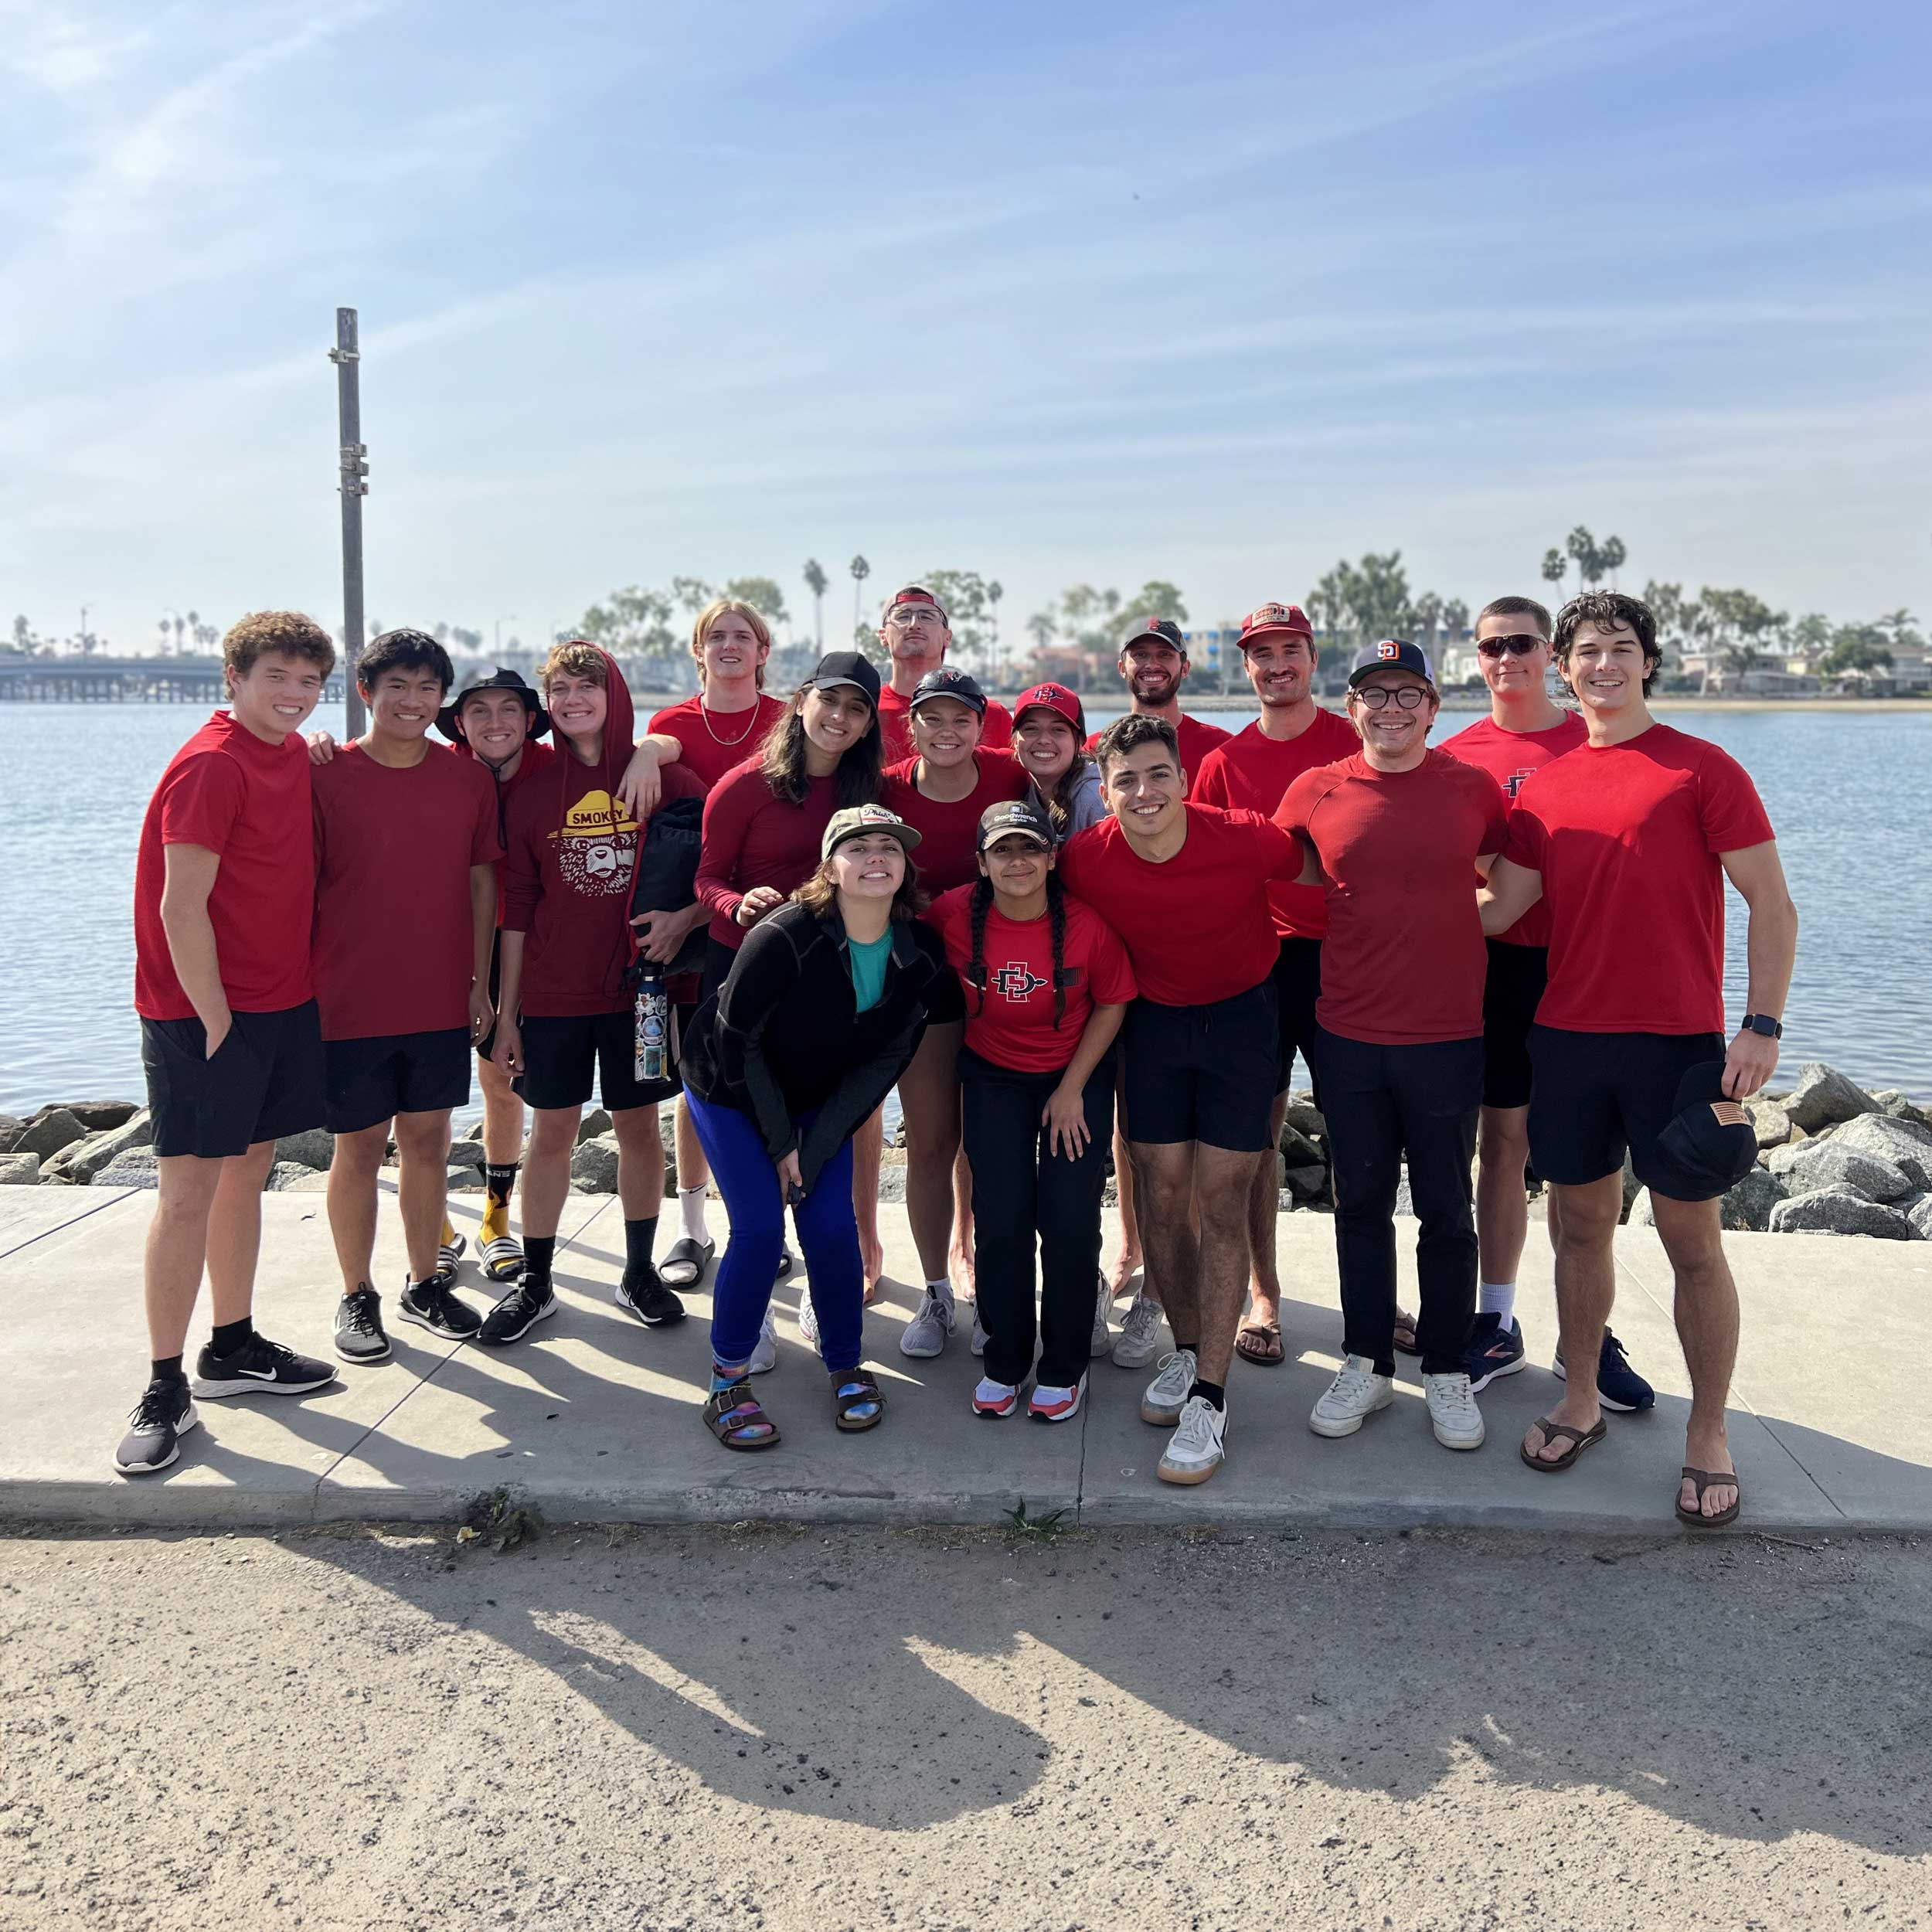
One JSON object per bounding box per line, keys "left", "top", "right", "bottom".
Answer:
{"left": 961, "top": 1047, "right": 1113, "bottom": 1389}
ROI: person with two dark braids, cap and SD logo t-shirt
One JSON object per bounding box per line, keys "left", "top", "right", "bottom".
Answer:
{"left": 931, "top": 800, "right": 1136, "bottom": 1422}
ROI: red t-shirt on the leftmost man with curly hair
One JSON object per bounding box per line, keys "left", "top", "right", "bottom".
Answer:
{"left": 134, "top": 711, "right": 315, "bottom": 1020}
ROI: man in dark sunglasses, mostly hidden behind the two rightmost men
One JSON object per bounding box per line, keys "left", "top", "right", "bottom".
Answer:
{"left": 1437, "top": 597, "right": 1656, "bottom": 1414}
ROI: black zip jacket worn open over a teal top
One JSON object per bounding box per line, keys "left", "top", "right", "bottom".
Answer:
{"left": 682, "top": 904, "right": 964, "bottom": 1194}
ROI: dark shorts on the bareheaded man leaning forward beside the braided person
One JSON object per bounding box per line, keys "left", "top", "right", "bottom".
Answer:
{"left": 1121, "top": 978, "right": 1281, "bottom": 1154}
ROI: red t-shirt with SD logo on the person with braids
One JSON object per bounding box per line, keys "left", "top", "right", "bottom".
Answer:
{"left": 926, "top": 885, "right": 1136, "bottom": 1074}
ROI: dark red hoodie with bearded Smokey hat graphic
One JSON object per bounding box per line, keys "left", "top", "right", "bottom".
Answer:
{"left": 502, "top": 651, "right": 706, "bottom": 1019}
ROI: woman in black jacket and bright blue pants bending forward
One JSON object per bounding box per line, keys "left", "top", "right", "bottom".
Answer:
{"left": 684, "top": 806, "right": 962, "bottom": 1449}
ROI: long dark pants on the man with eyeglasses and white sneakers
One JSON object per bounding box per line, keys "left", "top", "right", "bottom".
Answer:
{"left": 1316, "top": 1028, "right": 1484, "bottom": 1376}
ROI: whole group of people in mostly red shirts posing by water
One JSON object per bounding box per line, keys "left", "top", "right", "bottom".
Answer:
{"left": 116, "top": 586, "right": 1797, "bottom": 1526}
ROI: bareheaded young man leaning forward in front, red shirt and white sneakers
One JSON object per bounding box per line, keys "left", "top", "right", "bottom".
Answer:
{"left": 1059, "top": 715, "right": 1302, "bottom": 1482}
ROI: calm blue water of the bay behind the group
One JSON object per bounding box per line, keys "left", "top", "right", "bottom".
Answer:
{"left": 0, "top": 706, "right": 1932, "bottom": 1113}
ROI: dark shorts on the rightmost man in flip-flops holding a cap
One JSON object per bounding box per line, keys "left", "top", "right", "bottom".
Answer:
{"left": 1530, "top": 1026, "right": 1723, "bottom": 1202}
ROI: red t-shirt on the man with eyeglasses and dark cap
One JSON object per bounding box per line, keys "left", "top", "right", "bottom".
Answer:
{"left": 1275, "top": 750, "right": 1509, "bottom": 1047}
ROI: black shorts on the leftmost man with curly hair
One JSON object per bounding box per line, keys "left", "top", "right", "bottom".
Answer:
{"left": 141, "top": 999, "right": 327, "bottom": 1162}
